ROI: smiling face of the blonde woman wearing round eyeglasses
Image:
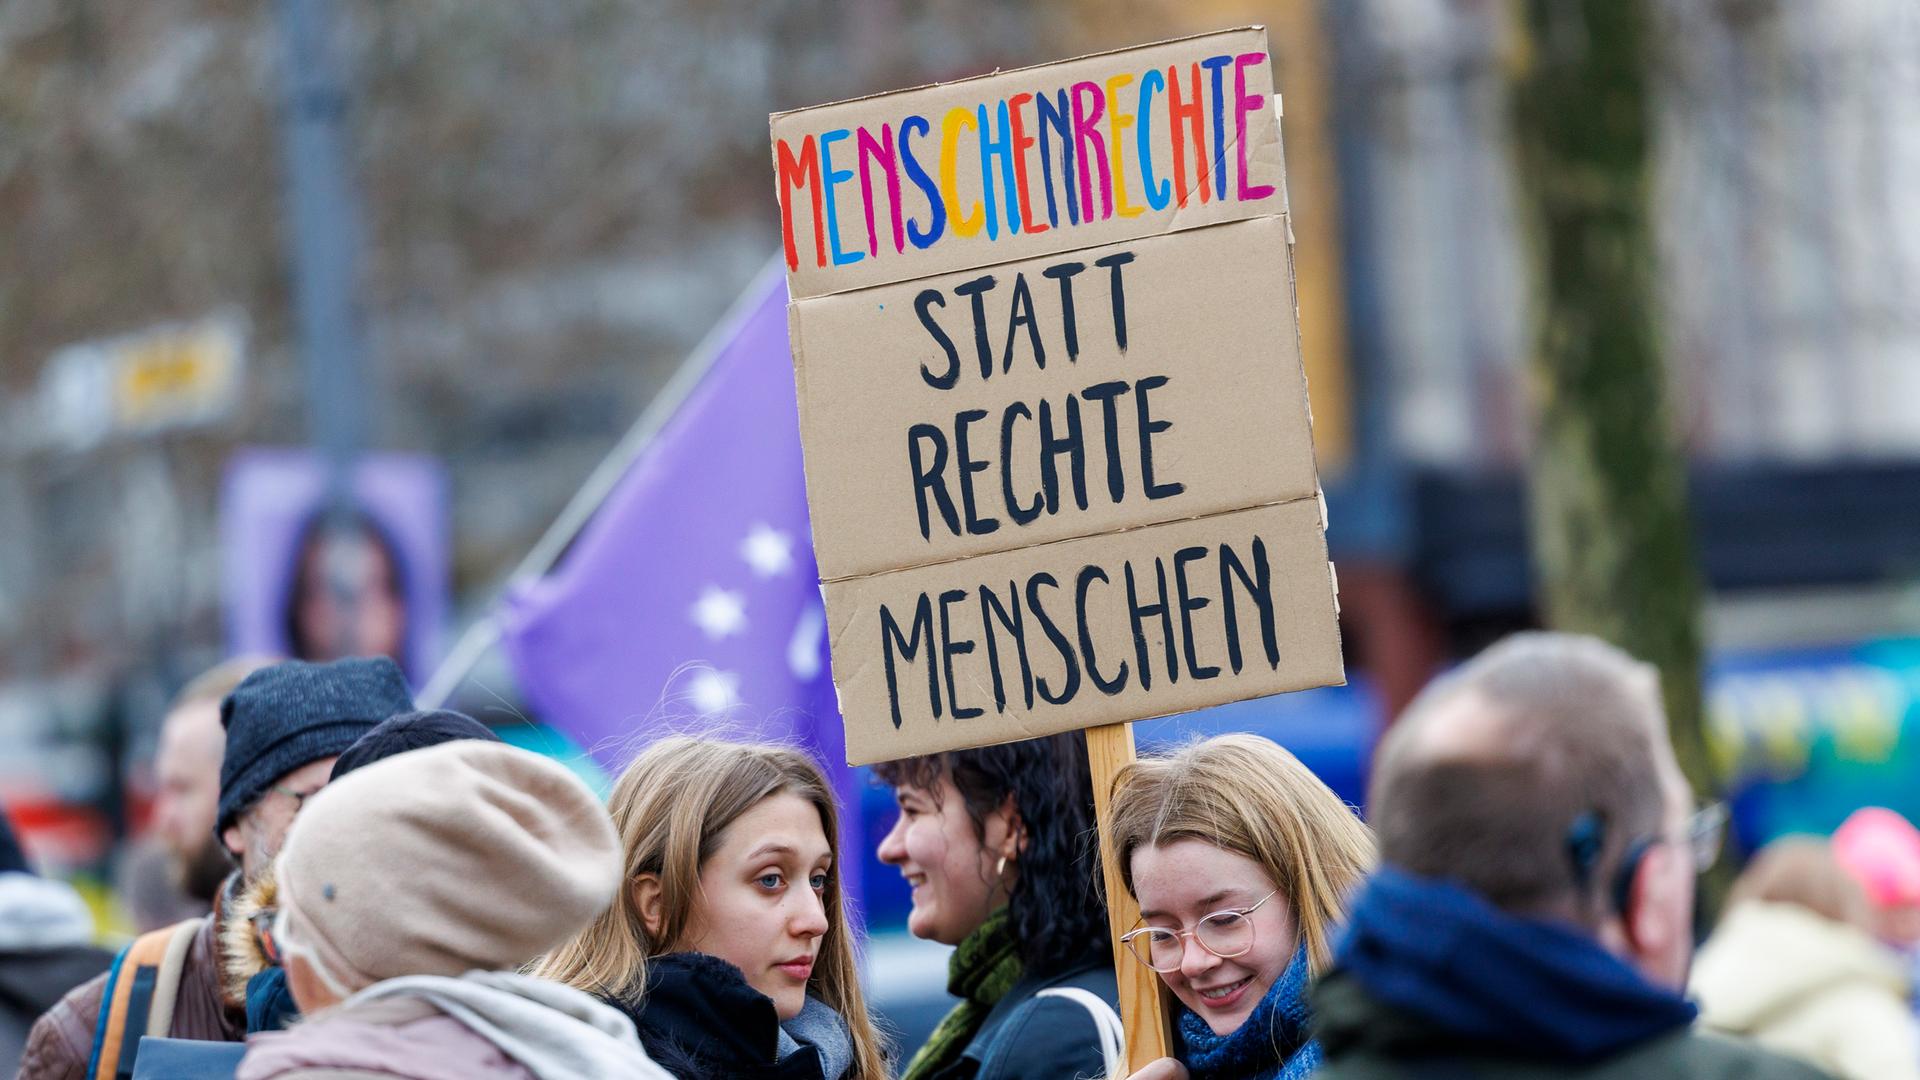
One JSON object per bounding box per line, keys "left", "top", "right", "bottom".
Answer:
{"left": 1133, "top": 840, "right": 1298, "bottom": 1036}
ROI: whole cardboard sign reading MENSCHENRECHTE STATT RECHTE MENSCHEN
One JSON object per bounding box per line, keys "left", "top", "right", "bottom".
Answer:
{"left": 772, "top": 29, "right": 1342, "bottom": 763}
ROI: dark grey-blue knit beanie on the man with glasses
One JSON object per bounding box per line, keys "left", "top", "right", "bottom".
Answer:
{"left": 213, "top": 657, "right": 413, "bottom": 836}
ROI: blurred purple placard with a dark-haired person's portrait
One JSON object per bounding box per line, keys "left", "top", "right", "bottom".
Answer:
{"left": 221, "top": 450, "right": 449, "bottom": 684}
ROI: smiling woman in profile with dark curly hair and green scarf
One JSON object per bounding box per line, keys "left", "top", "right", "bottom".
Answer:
{"left": 876, "top": 732, "right": 1119, "bottom": 1080}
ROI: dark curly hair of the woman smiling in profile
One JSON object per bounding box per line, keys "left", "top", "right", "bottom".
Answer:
{"left": 874, "top": 732, "right": 1114, "bottom": 976}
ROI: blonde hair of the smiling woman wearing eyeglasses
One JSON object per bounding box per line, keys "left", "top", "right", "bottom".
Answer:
{"left": 1110, "top": 734, "right": 1377, "bottom": 974}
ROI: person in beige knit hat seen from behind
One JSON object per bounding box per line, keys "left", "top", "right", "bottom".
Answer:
{"left": 238, "top": 742, "right": 666, "bottom": 1080}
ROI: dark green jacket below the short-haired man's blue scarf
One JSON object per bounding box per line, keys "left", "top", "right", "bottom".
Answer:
{"left": 1313, "top": 970, "right": 1826, "bottom": 1080}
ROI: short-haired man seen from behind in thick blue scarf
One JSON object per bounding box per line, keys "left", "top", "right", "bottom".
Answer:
{"left": 1313, "top": 634, "right": 1820, "bottom": 1080}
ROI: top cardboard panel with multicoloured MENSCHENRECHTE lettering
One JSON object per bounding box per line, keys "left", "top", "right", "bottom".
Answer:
{"left": 770, "top": 27, "right": 1284, "bottom": 300}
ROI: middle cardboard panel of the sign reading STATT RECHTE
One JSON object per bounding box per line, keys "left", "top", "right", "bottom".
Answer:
{"left": 789, "top": 217, "right": 1317, "bottom": 580}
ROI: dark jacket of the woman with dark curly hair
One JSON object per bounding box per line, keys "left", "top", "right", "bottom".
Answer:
{"left": 937, "top": 959, "right": 1119, "bottom": 1080}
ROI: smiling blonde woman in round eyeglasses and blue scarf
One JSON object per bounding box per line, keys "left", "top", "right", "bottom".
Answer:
{"left": 1110, "top": 734, "right": 1375, "bottom": 1080}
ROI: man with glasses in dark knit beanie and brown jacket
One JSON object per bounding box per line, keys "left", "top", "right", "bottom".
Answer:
{"left": 19, "top": 657, "right": 413, "bottom": 1080}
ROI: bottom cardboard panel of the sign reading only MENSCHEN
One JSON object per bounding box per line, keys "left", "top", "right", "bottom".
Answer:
{"left": 826, "top": 498, "right": 1342, "bottom": 765}
